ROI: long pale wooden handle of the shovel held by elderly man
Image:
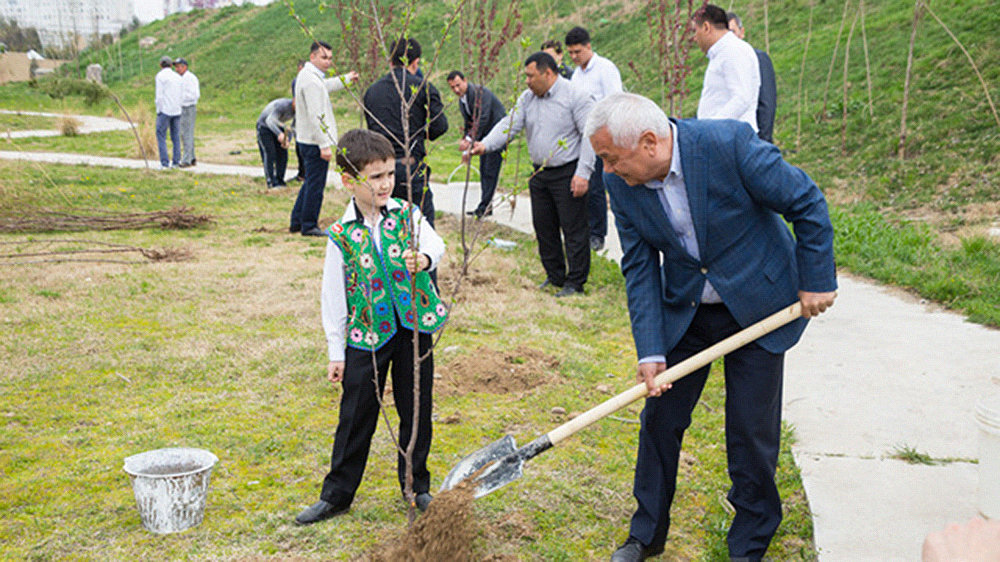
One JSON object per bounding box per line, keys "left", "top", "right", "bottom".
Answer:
{"left": 548, "top": 302, "right": 802, "bottom": 445}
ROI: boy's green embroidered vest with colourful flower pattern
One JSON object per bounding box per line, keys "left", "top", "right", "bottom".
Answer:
{"left": 327, "top": 199, "right": 448, "bottom": 351}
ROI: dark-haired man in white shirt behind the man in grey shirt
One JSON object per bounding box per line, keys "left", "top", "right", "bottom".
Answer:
{"left": 566, "top": 27, "right": 622, "bottom": 252}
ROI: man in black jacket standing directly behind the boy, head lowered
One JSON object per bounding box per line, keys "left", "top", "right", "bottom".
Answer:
{"left": 364, "top": 37, "right": 448, "bottom": 226}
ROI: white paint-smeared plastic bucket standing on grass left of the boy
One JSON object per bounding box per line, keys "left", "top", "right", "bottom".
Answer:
{"left": 123, "top": 448, "right": 219, "bottom": 534}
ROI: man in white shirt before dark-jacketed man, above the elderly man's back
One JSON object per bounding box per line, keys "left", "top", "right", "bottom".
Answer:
{"left": 691, "top": 4, "right": 760, "bottom": 132}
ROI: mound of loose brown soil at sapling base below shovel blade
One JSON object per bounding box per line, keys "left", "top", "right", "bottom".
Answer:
{"left": 360, "top": 480, "right": 477, "bottom": 562}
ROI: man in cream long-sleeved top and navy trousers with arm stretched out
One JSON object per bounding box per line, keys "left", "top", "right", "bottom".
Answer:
{"left": 288, "top": 41, "right": 358, "bottom": 236}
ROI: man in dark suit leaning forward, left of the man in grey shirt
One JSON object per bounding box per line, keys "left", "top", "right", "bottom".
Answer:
{"left": 448, "top": 70, "right": 507, "bottom": 218}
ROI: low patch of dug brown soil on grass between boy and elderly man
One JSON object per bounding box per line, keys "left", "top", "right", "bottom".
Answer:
{"left": 434, "top": 347, "right": 559, "bottom": 396}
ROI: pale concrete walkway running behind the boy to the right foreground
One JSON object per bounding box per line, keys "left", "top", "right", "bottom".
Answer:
{"left": 0, "top": 130, "right": 1000, "bottom": 562}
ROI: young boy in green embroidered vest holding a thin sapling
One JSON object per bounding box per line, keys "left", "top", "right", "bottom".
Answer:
{"left": 295, "top": 129, "right": 448, "bottom": 525}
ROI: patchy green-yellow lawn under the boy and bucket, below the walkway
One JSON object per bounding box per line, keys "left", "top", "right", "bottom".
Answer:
{"left": 0, "top": 162, "right": 815, "bottom": 560}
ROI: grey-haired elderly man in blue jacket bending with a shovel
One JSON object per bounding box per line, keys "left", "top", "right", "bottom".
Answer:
{"left": 585, "top": 93, "right": 837, "bottom": 561}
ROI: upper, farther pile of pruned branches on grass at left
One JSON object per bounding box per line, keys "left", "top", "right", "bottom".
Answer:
{"left": 0, "top": 207, "right": 212, "bottom": 232}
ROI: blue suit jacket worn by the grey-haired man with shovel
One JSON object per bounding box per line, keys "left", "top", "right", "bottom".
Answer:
{"left": 604, "top": 120, "right": 837, "bottom": 358}
